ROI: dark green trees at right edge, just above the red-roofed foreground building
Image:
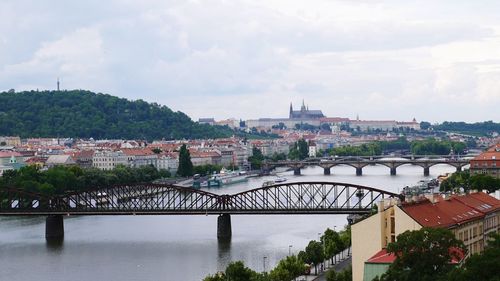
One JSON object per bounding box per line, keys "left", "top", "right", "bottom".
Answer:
{"left": 439, "top": 170, "right": 500, "bottom": 193}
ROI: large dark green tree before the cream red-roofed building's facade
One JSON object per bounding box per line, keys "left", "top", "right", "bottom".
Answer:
{"left": 380, "top": 227, "right": 465, "bottom": 281}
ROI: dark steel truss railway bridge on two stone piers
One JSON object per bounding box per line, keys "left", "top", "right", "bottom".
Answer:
{"left": 0, "top": 182, "right": 398, "bottom": 239}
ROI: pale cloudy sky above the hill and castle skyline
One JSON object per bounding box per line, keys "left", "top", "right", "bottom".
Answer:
{"left": 0, "top": 0, "right": 500, "bottom": 123}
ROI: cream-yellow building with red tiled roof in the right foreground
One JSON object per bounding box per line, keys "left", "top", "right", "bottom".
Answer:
{"left": 351, "top": 192, "right": 500, "bottom": 281}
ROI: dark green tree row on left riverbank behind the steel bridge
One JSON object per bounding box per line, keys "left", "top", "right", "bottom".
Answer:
{"left": 0, "top": 165, "right": 169, "bottom": 195}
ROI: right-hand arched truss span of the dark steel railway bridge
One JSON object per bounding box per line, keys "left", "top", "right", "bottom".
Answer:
{"left": 228, "top": 182, "right": 398, "bottom": 214}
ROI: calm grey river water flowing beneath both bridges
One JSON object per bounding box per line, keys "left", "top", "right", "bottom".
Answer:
{"left": 0, "top": 165, "right": 455, "bottom": 281}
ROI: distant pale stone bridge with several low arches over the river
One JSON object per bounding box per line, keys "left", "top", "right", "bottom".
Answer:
{"left": 262, "top": 155, "right": 470, "bottom": 176}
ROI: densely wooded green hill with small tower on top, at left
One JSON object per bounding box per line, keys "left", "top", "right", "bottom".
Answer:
{"left": 0, "top": 90, "right": 233, "bottom": 140}
